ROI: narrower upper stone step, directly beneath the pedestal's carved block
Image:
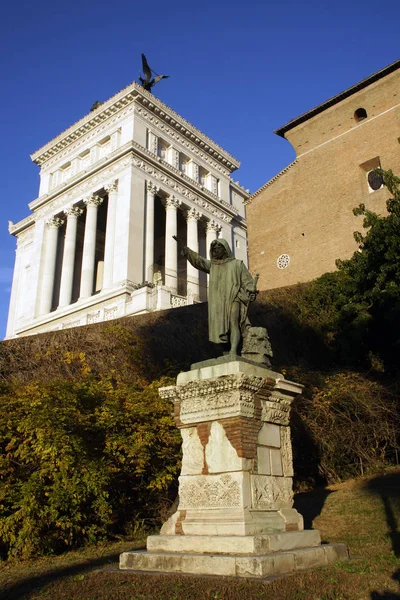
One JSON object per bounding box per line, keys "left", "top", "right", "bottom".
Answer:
{"left": 147, "top": 529, "right": 321, "bottom": 554}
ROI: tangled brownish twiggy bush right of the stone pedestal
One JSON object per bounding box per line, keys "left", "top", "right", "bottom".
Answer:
{"left": 291, "top": 371, "right": 400, "bottom": 481}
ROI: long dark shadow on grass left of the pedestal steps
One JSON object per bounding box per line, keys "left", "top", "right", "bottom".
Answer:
{"left": 0, "top": 546, "right": 144, "bottom": 600}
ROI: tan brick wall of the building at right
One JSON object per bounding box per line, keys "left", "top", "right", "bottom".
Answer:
{"left": 247, "top": 70, "right": 400, "bottom": 289}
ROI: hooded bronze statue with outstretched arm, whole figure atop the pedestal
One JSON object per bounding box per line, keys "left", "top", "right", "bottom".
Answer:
{"left": 173, "top": 236, "right": 258, "bottom": 358}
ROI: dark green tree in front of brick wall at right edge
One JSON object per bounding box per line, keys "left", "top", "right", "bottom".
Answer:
{"left": 337, "top": 164, "right": 400, "bottom": 372}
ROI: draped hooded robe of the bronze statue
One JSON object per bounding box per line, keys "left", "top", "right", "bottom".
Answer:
{"left": 184, "top": 239, "right": 256, "bottom": 344}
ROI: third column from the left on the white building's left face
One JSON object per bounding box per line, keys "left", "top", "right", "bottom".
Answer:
{"left": 80, "top": 196, "right": 103, "bottom": 298}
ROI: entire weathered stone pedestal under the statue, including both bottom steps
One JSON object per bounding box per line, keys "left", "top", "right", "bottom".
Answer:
{"left": 120, "top": 357, "right": 347, "bottom": 577}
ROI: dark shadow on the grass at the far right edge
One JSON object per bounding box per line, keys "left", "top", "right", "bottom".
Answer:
{"left": 366, "top": 472, "right": 400, "bottom": 600}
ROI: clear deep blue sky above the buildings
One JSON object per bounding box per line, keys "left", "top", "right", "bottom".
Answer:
{"left": 0, "top": 0, "right": 400, "bottom": 338}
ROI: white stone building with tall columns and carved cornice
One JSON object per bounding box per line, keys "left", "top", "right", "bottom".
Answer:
{"left": 7, "top": 83, "right": 249, "bottom": 338}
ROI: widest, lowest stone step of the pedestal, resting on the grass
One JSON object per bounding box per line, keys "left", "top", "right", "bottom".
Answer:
{"left": 119, "top": 536, "right": 348, "bottom": 578}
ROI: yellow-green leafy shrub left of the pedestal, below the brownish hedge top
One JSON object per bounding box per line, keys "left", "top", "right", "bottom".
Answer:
{"left": 0, "top": 352, "right": 180, "bottom": 557}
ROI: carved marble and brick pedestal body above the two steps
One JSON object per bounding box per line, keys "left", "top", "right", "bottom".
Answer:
{"left": 160, "top": 360, "right": 303, "bottom": 535}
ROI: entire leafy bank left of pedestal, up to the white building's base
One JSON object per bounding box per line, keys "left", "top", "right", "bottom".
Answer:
{"left": 0, "top": 306, "right": 212, "bottom": 557}
